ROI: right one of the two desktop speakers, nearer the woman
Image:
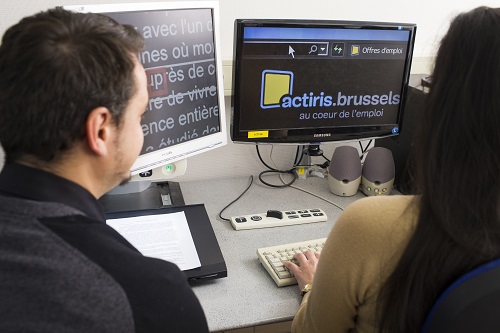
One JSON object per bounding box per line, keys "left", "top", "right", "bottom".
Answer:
{"left": 361, "top": 147, "right": 395, "bottom": 196}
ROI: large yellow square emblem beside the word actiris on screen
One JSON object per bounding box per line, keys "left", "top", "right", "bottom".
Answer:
{"left": 260, "top": 70, "right": 293, "bottom": 109}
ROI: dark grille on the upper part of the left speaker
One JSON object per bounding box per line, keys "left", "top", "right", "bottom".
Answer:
{"left": 328, "top": 146, "right": 361, "bottom": 181}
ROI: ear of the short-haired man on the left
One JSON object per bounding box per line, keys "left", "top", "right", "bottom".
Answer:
{"left": 85, "top": 107, "right": 114, "bottom": 156}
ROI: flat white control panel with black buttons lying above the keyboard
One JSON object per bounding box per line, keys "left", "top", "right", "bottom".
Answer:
{"left": 231, "top": 208, "right": 327, "bottom": 230}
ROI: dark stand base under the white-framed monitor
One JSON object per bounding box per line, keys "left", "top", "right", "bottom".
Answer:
{"left": 99, "top": 180, "right": 185, "bottom": 213}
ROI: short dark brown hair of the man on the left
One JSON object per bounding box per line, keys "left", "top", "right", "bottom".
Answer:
{"left": 0, "top": 8, "right": 144, "bottom": 162}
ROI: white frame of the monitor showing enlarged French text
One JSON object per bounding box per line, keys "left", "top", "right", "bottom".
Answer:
{"left": 63, "top": 1, "right": 228, "bottom": 175}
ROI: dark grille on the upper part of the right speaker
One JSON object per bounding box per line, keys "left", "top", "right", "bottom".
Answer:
{"left": 363, "top": 147, "right": 395, "bottom": 183}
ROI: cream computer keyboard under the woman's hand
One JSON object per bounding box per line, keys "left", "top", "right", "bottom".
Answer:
{"left": 257, "top": 238, "right": 326, "bottom": 287}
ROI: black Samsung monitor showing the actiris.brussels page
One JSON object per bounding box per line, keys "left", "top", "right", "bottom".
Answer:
{"left": 231, "top": 19, "right": 416, "bottom": 144}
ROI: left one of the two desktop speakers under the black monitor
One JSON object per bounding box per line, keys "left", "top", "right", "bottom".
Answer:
{"left": 328, "top": 146, "right": 361, "bottom": 197}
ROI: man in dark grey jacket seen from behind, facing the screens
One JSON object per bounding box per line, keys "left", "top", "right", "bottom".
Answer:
{"left": 0, "top": 9, "right": 208, "bottom": 333}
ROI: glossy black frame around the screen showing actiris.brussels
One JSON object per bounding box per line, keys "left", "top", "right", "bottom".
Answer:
{"left": 230, "top": 19, "right": 417, "bottom": 145}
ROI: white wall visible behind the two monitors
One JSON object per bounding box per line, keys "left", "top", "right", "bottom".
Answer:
{"left": 0, "top": 0, "right": 498, "bottom": 180}
